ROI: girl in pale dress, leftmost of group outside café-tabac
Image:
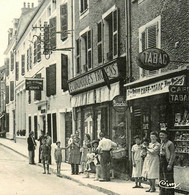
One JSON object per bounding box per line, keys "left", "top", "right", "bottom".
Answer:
{"left": 131, "top": 135, "right": 143, "bottom": 188}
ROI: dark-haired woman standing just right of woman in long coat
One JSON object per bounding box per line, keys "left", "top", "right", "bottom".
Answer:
{"left": 81, "top": 134, "right": 91, "bottom": 173}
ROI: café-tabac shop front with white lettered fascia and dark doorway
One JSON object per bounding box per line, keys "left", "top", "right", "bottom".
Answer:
{"left": 126, "top": 69, "right": 189, "bottom": 189}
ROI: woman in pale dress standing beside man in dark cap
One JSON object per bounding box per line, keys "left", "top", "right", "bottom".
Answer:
{"left": 142, "top": 132, "right": 160, "bottom": 192}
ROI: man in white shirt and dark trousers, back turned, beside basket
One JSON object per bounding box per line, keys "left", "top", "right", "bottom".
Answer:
{"left": 98, "top": 133, "right": 117, "bottom": 182}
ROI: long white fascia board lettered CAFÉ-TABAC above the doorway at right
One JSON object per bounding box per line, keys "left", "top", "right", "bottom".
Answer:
{"left": 127, "top": 75, "right": 185, "bottom": 100}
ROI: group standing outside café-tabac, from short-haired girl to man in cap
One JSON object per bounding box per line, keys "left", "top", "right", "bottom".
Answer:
{"left": 131, "top": 130, "right": 175, "bottom": 195}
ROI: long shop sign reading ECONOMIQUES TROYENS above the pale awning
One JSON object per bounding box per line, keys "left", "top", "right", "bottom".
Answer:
{"left": 68, "top": 63, "right": 119, "bottom": 94}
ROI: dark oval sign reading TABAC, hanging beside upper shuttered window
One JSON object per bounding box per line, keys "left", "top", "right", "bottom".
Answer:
{"left": 138, "top": 48, "right": 170, "bottom": 70}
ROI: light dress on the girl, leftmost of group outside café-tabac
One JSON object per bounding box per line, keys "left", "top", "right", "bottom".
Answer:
{"left": 131, "top": 144, "right": 142, "bottom": 177}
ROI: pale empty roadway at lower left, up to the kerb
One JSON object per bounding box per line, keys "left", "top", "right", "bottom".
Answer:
{"left": 0, "top": 146, "right": 103, "bottom": 195}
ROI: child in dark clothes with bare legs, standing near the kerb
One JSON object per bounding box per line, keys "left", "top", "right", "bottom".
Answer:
{"left": 41, "top": 139, "right": 50, "bottom": 174}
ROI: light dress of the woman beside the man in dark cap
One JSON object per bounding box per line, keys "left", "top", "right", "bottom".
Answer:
{"left": 142, "top": 142, "right": 160, "bottom": 179}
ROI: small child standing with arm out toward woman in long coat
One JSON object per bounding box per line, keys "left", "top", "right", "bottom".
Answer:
{"left": 54, "top": 141, "right": 65, "bottom": 177}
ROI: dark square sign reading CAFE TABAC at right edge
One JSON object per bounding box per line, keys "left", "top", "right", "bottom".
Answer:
{"left": 169, "top": 85, "right": 189, "bottom": 103}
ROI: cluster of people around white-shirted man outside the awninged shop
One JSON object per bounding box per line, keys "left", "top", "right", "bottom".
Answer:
{"left": 68, "top": 131, "right": 117, "bottom": 181}
